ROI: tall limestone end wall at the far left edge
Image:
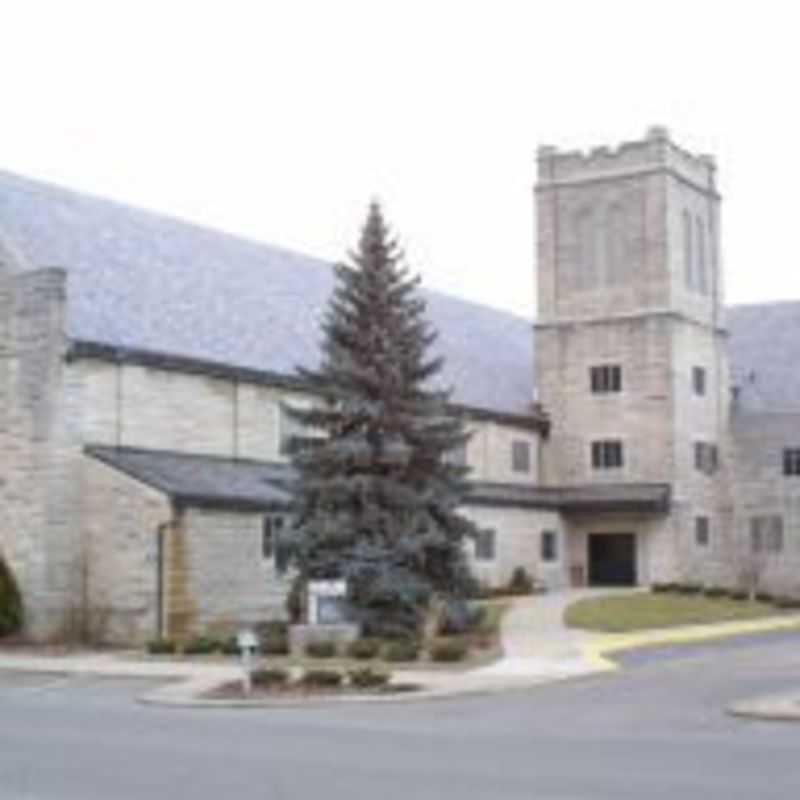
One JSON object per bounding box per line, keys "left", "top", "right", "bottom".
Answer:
{"left": 0, "top": 269, "right": 84, "bottom": 638}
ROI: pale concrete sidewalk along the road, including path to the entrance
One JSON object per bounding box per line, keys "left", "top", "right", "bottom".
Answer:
{"left": 0, "top": 589, "right": 800, "bottom": 706}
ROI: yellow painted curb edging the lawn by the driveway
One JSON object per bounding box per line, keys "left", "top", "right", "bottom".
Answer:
{"left": 583, "top": 614, "right": 800, "bottom": 672}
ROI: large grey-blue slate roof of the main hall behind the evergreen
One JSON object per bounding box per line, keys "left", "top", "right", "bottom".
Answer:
{"left": 0, "top": 172, "right": 533, "bottom": 414}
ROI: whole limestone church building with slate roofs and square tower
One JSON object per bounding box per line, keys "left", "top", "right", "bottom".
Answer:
{"left": 0, "top": 128, "right": 800, "bottom": 643}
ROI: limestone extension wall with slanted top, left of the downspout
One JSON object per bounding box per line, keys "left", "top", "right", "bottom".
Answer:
{"left": 82, "top": 456, "right": 172, "bottom": 644}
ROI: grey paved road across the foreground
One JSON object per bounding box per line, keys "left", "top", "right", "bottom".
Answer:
{"left": 0, "top": 634, "right": 800, "bottom": 800}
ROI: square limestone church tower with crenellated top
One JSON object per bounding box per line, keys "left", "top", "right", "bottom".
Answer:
{"left": 535, "top": 128, "right": 729, "bottom": 582}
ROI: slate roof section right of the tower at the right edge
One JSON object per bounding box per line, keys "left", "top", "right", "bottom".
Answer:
{"left": 728, "top": 301, "right": 800, "bottom": 412}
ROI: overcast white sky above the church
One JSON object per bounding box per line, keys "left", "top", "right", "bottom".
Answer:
{"left": 0, "top": 0, "right": 800, "bottom": 316}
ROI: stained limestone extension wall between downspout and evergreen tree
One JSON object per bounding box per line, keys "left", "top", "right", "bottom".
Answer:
{"left": 165, "top": 508, "right": 290, "bottom": 635}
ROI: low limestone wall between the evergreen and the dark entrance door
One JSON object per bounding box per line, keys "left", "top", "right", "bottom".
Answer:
{"left": 463, "top": 506, "right": 567, "bottom": 588}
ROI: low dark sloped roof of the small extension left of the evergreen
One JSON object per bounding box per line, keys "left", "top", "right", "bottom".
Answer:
{"left": 86, "top": 446, "right": 291, "bottom": 510}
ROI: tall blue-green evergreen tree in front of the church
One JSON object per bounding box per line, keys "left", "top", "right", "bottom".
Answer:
{"left": 288, "top": 203, "right": 474, "bottom": 634}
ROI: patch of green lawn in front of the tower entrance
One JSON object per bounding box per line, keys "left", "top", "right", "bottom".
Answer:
{"left": 564, "top": 592, "right": 781, "bottom": 633}
